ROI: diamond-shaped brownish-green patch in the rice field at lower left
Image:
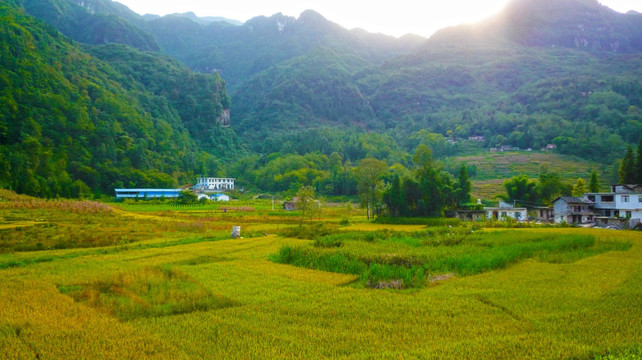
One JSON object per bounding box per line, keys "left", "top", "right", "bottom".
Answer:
{"left": 58, "top": 267, "right": 238, "bottom": 321}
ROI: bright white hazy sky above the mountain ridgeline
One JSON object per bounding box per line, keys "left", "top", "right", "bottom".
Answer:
{"left": 118, "top": 0, "right": 642, "bottom": 37}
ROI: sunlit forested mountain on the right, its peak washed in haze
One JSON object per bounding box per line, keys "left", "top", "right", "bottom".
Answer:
{"left": 233, "top": 0, "right": 642, "bottom": 161}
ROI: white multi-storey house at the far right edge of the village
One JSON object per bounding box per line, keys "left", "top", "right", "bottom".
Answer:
{"left": 584, "top": 184, "right": 642, "bottom": 219}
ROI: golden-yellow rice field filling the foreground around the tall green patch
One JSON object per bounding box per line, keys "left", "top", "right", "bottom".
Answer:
{"left": 0, "top": 191, "right": 642, "bottom": 359}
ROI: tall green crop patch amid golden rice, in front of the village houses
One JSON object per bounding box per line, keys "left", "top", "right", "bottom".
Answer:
{"left": 271, "top": 231, "right": 631, "bottom": 289}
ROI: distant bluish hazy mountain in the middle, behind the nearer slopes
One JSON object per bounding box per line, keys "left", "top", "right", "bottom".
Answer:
{"left": 149, "top": 10, "right": 425, "bottom": 90}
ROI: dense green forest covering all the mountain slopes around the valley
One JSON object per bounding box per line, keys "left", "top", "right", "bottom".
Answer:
{"left": 0, "top": 0, "right": 642, "bottom": 204}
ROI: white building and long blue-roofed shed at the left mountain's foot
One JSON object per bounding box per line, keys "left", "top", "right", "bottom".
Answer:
{"left": 115, "top": 177, "right": 236, "bottom": 201}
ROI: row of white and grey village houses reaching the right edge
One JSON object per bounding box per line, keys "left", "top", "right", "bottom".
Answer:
{"left": 449, "top": 184, "right": 642, "bottom": 228}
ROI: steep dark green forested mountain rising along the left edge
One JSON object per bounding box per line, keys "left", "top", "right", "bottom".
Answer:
{"left": 0, "top": 3, "right": 227, "bottom": 197}
